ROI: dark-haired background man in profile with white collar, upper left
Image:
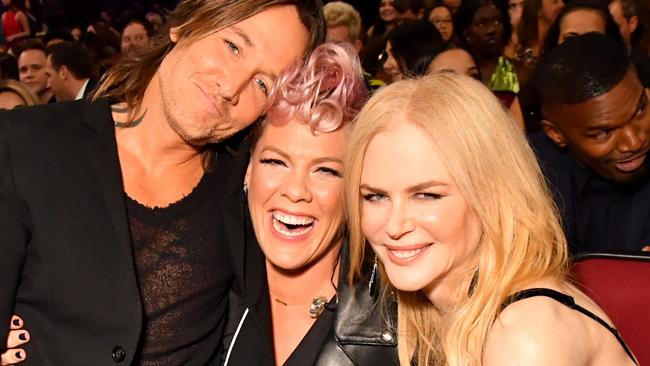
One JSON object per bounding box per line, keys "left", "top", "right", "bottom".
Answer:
{"left": 45, "top": 42, "right": 97, "bottom": 102}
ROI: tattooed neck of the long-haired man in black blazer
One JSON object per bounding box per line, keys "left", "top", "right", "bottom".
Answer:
{"left": 113, "top": 74, "right": 203, "bottom": 173}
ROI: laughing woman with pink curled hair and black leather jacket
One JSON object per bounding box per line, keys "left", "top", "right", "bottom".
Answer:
{"left": 224, "top": 44, "right": 397, "bottom": 365}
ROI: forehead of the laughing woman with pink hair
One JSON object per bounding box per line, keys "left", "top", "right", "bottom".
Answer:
{"left": 255, "top": 119, "right": 347, "bottom": 159}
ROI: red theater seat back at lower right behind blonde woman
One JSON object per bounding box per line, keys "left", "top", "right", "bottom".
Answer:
{"left": 572, "top": 253, "right": 650, "bottom": 365}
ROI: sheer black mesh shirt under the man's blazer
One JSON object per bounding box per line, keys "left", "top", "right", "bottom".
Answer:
{"left": 127, "top": 164, "right": 233, "bottom": 366}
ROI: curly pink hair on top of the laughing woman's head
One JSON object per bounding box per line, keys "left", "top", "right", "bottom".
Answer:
{"left": 267, "top": 43, "right": 368, "bottom": 132}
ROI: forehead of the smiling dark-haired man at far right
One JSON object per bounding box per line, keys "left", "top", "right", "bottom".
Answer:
{"left": 547, "top": 68, "right": 644, "bottom": 130}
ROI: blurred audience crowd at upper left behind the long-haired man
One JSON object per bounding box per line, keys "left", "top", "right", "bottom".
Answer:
{"left": 0, "top": 0, "right": 168, "bottom": 109}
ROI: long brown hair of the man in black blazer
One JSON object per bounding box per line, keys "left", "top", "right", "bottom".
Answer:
{"left": 93, "top": 0, "right": 325, "bottom": 116}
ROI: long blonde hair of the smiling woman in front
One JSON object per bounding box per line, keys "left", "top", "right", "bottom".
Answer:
{"left": 345, "top": 73, "right": 567, "bottom": 366}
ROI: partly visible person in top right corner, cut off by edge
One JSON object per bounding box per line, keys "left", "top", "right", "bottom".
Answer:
{"left": 609, "top": 0, "right": 650, "bottom": 87}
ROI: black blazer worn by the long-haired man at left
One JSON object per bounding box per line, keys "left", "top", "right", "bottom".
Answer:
{"left": 0, "top": 101, "right": 142, "bottom": 365}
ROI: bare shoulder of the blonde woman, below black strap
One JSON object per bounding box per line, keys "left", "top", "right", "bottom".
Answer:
{"left": 484, "top": 290, "right": 589, "bottom": 366}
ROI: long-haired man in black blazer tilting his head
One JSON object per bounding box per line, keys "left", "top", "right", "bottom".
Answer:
{"left": 0, "top": 0, "right": 324, "bottom": 365}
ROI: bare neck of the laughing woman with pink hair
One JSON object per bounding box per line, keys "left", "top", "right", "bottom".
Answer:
{"left": 266, "top": 242, "right": 341, "bottom": 305}
